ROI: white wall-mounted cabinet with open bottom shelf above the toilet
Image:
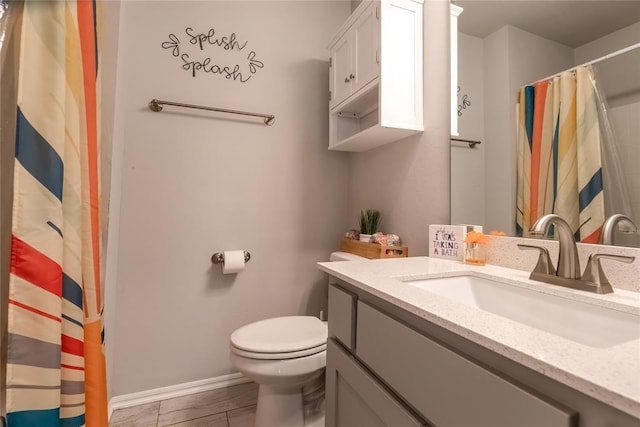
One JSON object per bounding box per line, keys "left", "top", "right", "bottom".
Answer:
{"left": 329, "top": 0, "right": 424, "bottom": 151}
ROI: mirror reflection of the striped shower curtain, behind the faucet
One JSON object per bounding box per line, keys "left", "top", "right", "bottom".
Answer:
{"left": 516, "top": 66, "right": 605, "bottom": 243}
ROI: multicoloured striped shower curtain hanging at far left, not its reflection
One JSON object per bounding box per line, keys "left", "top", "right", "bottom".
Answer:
{"left": 6, "top": 0, "right": 107, "bottom": 427}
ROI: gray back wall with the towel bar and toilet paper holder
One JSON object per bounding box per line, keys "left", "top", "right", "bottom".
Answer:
{"left": 106, "top": 1, "right": 350, "bottom": 396}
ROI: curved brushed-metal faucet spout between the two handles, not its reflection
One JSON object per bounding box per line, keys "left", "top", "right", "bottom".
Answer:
{"left": 530, "top": 214, "right": 580, "bottom": 279}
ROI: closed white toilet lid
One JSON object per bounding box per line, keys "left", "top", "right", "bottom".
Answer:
{"left": 231, "top": 316, "right": 328, "bottom": 353}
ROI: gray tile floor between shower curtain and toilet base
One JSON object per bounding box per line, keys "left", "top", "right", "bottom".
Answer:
{"left": 109, "top": 383, "right": 258, "bottom": 427}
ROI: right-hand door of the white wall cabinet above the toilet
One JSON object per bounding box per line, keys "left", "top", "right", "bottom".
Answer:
{"left": 349, "top": 2, "right": 380, "bottom": 93}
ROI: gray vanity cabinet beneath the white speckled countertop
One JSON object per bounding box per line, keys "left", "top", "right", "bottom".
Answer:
{"left": 326, "top": 278, "right": 638, "bottom": 427}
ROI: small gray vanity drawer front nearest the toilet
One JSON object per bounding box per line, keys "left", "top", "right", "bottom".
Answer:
{"left": 329, "top": 284, "right": 358, "bottom": 351}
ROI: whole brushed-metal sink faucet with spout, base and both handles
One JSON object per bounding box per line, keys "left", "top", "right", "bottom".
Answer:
{"left": 518, "top": 214, "right": 635, "bottom": 294}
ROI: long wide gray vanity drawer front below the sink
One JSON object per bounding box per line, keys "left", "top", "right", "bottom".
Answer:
{"left": 356, "top": 302, "right": 577, "bottom": 427}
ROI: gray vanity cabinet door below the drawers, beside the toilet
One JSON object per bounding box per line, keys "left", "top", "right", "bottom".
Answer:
{"left": 325, "top": 338, "right": 425, "bottom": 427}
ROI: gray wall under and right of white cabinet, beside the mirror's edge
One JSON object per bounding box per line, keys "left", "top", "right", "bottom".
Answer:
{"left": 348, "top": 1, "right": 450, "bottom": 256}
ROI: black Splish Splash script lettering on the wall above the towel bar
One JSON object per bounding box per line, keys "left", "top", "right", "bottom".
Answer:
{"left": 162, "top": 27, "right": 264, "bottom": 83}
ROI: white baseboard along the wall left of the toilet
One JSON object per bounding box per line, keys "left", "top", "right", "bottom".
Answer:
{"left": 109, "top": 372, "right": 251, "bottom": 419}
